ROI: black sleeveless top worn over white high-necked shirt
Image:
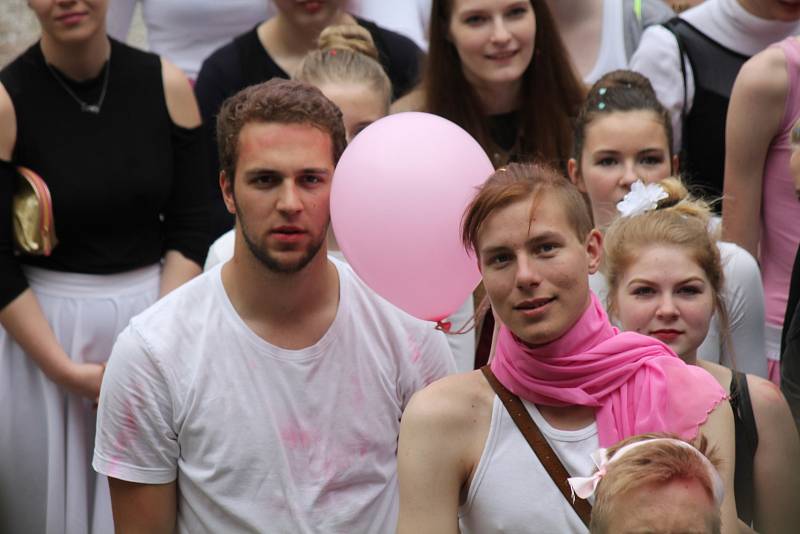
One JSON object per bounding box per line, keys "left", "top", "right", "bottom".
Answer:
{"left": 664, "top": 17, "right": 750, "bottom": 207}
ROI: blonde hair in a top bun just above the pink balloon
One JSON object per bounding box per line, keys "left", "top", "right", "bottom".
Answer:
{"left": 294, "top": 24, "right": 392, "bottom": 113}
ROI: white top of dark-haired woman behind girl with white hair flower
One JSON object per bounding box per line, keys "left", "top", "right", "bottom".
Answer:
{"left": 589, "top": 241, "right": 767, "bottom": 378}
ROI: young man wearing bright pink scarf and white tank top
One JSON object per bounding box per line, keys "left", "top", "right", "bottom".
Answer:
{"left": 398, "top": 164, "right": 739, "bottom": 534}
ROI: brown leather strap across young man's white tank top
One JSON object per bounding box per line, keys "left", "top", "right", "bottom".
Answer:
{"left": 481, "top": 365, "right": 592, "bottom": 528}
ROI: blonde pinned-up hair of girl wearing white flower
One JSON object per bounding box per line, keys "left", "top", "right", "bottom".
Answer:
{"left": 602, "top": 177, "right": 732, "bottom": 360}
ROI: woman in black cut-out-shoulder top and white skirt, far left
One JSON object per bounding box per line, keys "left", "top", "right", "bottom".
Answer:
{"left": 0, "top": 0, "right": 209, "bottom": 533}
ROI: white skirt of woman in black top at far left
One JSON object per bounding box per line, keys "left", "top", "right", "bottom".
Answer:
{"left": 0, "top": 265, "right": 160, "bottom": 534}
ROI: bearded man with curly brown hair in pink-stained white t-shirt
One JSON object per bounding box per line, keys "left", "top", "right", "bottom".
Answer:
{"left": 94, "top": 80, "right": 453, "bottom": 532}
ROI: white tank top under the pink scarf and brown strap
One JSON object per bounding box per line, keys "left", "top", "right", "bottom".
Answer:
{"left": 458, "top": 395, "right": 599, "bottom": 534}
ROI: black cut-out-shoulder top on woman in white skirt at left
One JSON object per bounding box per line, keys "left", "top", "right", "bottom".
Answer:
{"left": 0, "top": 40, "right": 210, "bottom": 308}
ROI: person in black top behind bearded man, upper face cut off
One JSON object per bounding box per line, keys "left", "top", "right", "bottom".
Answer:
{"left": 195, "top": 0, "right": 422, "bottom": 237}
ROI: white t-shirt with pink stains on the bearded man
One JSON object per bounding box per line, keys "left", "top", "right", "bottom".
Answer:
{"left": 93, "top": 261, "right": 453, "bottom": 533}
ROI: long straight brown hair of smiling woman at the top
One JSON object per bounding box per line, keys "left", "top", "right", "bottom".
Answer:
{"left": 423, "top": 0, "right": 584, "bottom": 167}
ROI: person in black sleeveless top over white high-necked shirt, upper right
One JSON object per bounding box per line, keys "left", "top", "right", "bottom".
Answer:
{"left": 630, "top": 0, "right": 800, "bottom": 200}
